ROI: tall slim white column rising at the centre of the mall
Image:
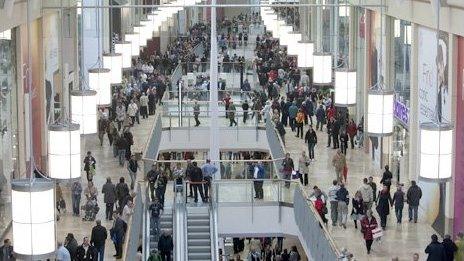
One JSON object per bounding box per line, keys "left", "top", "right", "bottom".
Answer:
{"left": 209, "top": 0, "right": 221, "bottom": 179}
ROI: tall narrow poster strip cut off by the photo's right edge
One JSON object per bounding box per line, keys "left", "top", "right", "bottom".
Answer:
{"left": 453, "top": 37, "right": 464, "bottom": 236}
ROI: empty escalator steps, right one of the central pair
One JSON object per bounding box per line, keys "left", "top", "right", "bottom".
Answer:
{"left": 187, "top": 206, "right": 211, "bottom": 261}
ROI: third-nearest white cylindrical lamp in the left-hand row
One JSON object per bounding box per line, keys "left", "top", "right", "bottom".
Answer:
{"left": 71, "top": 90, "right": 97, "bottom": 134}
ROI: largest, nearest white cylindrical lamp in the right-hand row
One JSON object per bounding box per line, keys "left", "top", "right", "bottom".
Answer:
{"left": 419, "top": 123, "right": 453, "bottom": 181}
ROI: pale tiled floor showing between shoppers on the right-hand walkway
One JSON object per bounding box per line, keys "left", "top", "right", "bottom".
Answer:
{"left": 285, "top": 126, "right": 435, "bottom": 260}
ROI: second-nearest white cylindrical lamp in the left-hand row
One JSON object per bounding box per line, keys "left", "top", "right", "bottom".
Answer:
{"left": 48, "top": 123, "right": 81, "bottom": 180}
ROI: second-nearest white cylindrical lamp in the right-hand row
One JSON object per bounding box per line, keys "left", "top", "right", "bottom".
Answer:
{"left": 367, "top": 91, "right": 394, "bottom": 136}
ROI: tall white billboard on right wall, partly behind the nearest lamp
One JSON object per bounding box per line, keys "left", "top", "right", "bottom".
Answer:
{"left": 417, "top": 26, "right": 452, "bottom": 234}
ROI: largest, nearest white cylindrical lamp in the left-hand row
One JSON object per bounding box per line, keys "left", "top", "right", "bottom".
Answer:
{"left": 11, "top": 179, "right": 56, "bottom": 260}
